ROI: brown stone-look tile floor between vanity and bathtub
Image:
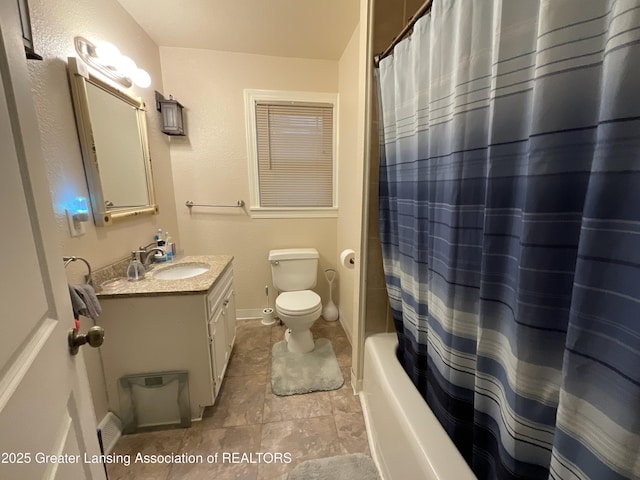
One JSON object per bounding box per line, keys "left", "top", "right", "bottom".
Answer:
{"left": 108, "top": 318, "right": 369, "bottom": 480}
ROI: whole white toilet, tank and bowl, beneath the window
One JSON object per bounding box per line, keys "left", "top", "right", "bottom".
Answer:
{"left": 269, "top": 248, "right": 322, "bottom": 353}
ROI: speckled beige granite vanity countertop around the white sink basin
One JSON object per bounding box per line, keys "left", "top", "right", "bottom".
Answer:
{"left": 96, "top": 255, "right": 233, "bottom": 299}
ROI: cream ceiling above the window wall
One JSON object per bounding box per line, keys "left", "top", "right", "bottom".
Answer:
{"left": 118, "top": 0, "right": 360, "bottom": 60}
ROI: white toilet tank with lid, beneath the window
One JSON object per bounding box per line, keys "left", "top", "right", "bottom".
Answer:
{"left": 269, "top": 248, "right": 320, "bottom": 292}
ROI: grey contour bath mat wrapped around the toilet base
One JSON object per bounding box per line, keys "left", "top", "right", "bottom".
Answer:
{"left": 271, "top": 338, "right": 344, "bottom": 396}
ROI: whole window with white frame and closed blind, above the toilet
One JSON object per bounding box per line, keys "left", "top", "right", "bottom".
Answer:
{"left": 245, "top": 90, "right": 337, "bottom": 217}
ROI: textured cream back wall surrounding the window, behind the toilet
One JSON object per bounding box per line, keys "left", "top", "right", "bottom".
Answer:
{"left": 160, "top": 47, "right": 342, "bottom": 315}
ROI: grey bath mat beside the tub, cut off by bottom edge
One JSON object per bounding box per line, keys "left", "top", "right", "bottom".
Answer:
{"left": 287, "top": 453, "right": 380, "bottom": 480}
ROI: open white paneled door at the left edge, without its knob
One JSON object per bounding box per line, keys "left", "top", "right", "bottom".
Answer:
{"left": 0, "top": 0, "right": 105, "bottom": 480}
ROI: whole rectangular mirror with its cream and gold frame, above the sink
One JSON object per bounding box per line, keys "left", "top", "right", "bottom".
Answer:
{"left": 68, "top": 57, "right": 158, "bottom": 226}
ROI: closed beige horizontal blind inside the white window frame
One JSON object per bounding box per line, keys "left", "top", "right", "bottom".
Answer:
{"left": 256, "top": 102, "right": 333, "bottom": 208}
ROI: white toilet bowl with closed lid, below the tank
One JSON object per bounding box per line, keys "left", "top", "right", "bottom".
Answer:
{"left": 276, "top": 290, "right": 322, "bottom": 353}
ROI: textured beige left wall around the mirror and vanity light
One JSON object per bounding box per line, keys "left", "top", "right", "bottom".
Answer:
{"left": 29, "top": 0, "right": 179, "bottom": 421}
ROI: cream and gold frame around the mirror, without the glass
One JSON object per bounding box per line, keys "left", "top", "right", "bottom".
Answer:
{"left": 67, "top": 57, "right": 159, "bottom": 227}
